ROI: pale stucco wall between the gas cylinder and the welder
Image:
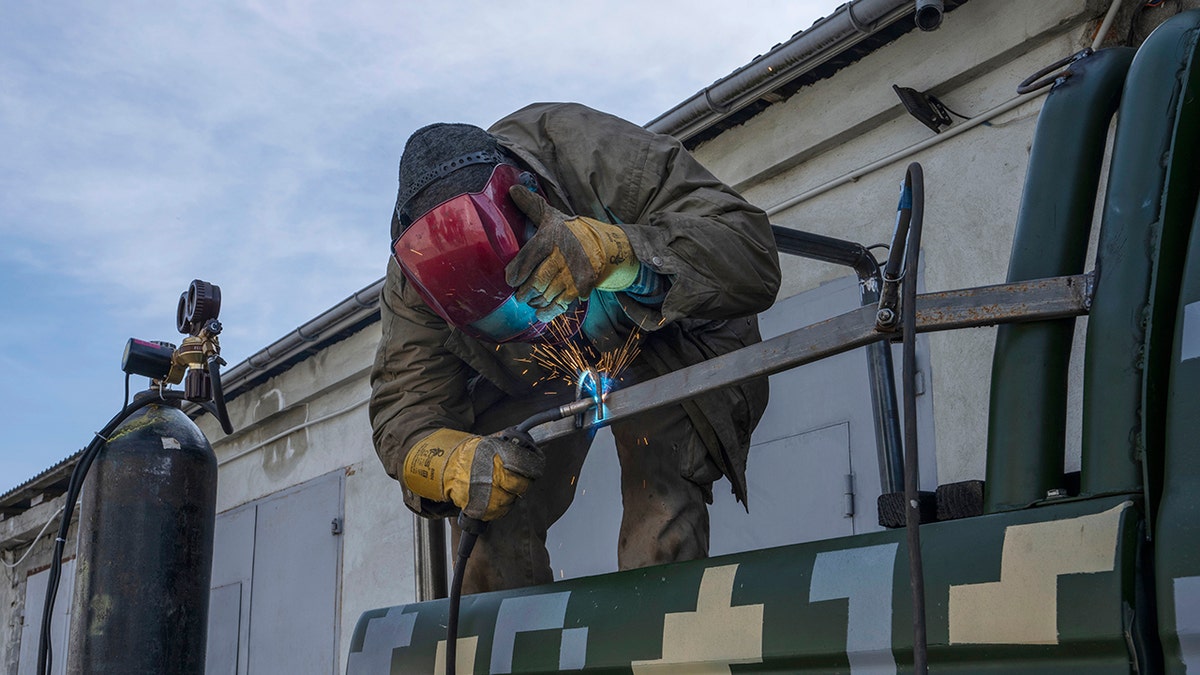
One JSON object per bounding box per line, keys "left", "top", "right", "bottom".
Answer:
{"left": 198, "top": 324, "right": 415, "bottom": 671}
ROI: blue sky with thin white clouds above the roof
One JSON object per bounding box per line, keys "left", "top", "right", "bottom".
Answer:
{"left": 0, "top": 0, "right": 840, "bottom": 492}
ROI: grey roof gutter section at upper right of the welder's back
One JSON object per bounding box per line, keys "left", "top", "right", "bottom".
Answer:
{"left": 646, "top": 0, "right": 916, "bottom": 141}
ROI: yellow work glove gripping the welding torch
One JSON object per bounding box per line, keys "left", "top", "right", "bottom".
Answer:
{"left": 403, "top": 429, "right": 546, "bottom": 520}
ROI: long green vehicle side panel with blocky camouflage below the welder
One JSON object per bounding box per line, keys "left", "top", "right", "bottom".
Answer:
{"left": 347, "top": 497, "right": 1141, "bottom": 675}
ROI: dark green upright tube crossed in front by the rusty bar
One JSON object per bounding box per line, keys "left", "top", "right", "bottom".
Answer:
{"left": 984, "top": 48, "right": 1134, "bottom": 513}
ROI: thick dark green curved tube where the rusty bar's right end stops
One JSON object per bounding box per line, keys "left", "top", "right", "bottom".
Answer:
{"left": 1080, "top": 11, "right": 1200, "bottom": 497}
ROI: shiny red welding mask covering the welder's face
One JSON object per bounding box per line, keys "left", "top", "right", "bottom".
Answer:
{"left": 391, "top": 165, "right": 586, "bottom": 342}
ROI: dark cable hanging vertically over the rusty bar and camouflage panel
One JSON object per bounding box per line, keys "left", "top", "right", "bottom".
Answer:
{"left": 900, "top": 162, "right": 929, "bottom": 675}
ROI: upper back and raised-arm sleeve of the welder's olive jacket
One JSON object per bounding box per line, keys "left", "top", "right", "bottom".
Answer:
{"left": 492, "top": 103, "right": 780, "bottom": 329}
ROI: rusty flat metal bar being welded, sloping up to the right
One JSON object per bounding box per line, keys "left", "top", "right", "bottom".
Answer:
{"left": 530, "top": 274, "right": 1093, "bottom": 441}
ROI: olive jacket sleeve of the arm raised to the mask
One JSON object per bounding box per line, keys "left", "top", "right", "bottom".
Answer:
{"left": 623, "top": 132, "right": 780, "bottom": 322}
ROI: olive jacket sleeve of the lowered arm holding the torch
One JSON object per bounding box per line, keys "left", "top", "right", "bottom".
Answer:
{"left": 370, "top": 259, "right": 474, "bottom": 515}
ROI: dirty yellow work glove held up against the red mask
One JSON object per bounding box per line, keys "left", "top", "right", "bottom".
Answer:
{"left": 505, "top": 185, "right": 640, "bottom": 322}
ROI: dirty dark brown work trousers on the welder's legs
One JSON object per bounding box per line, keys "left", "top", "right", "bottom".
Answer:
{"left": 451, "top": 374, "right": 720, "bottom": 593}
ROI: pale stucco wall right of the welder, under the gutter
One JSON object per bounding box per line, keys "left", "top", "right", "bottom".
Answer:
{"left": 696, "top": 0, "right": 1106, "bottom": 483}
